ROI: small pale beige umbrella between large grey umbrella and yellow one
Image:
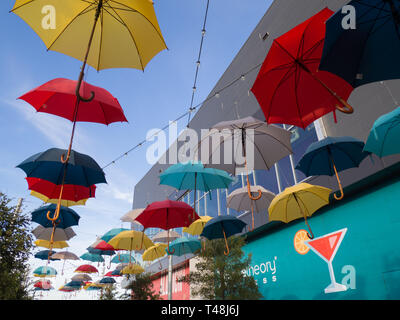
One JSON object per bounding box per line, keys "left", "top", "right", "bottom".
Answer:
{"left": 226, "top": 186, "right": 275, "bottom": 231}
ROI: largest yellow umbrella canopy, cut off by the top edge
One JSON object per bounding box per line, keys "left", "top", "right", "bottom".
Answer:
{"left": 12, "top": 0, "right": 166, "bottom": 70}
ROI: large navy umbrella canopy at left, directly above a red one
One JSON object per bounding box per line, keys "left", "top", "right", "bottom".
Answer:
{"left": 17, "top": 148, "right": 107, "bottom": 188}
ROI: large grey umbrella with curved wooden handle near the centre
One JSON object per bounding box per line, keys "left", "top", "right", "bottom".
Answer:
{"left": 198, "top": 117, "right": 293, "bottom": 200}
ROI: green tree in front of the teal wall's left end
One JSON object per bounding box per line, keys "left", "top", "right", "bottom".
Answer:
{"left": 179, "top": 236, "right": 262, "bottom": 300}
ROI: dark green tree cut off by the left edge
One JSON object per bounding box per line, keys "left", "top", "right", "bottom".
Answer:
{"left": 0, "top": 192, "right": 32, "bottom": 300}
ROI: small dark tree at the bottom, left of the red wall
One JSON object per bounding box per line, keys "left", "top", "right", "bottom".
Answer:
{"left": 121, "top": 273, "right": 160, "bottom": 300}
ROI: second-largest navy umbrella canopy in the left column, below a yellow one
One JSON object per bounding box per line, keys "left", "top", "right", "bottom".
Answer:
{"left": 32, "top": 204, "right": 80, "bottom": 229}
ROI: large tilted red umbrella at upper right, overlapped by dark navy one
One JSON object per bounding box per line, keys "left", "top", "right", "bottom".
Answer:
{"left": 251, "top": 8, "right": 353, "bottom": 129}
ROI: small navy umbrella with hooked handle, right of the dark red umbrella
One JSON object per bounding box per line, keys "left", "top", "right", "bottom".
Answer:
{"left": 201, "top": 216, "right": 246, "bottom": 256}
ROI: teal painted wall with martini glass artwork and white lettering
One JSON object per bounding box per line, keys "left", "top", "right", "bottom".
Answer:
{"left": 244, "top": 182, "right": 400, "bottom": 300}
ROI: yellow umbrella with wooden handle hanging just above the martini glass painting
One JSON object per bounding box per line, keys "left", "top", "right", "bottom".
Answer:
{"left": 268, "top": 183, "right": 332, "bottom": 239}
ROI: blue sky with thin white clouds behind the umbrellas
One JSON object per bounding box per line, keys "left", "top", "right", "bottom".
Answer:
{"left": 0, "top": 0, "right": 272, "bottom": 298}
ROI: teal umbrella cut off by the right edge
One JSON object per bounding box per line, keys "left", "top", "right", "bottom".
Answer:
{"left": 364, "top": 107, "right": 400, "bottom": 157}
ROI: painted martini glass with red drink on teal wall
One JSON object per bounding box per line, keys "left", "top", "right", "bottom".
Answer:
{"left": 304, "top": 228, "right": 347, "bottom": 293}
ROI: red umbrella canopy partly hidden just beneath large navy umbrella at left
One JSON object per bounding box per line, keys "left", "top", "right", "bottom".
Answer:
{"left": 25, "top": 177, "right": 96, "bottom": 202}
